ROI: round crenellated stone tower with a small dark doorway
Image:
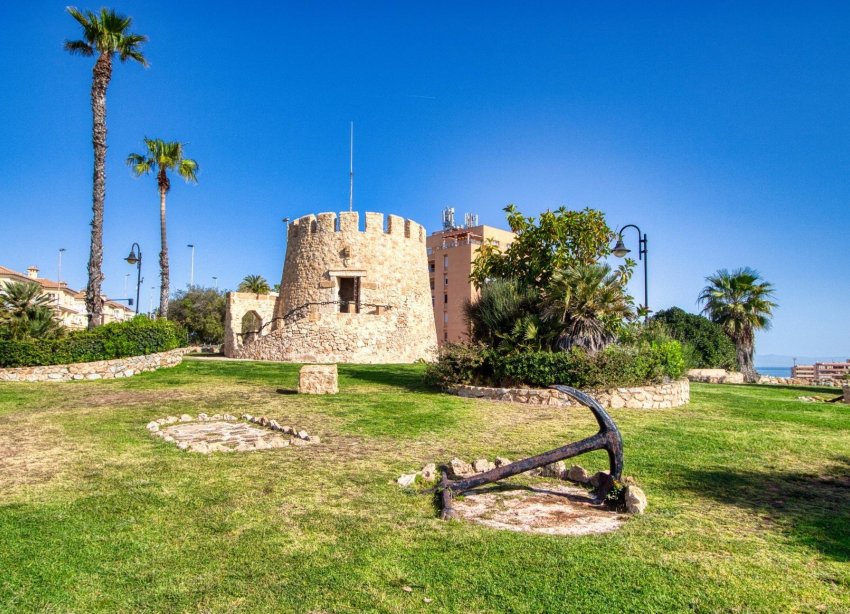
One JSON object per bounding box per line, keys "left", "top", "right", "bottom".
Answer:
{"left": 231, "top": 212, "right": 437, "bottom": 363}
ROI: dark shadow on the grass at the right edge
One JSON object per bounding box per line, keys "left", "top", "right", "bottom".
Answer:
{"left": 683, "top": 456, "right": 850, "bottom": 561}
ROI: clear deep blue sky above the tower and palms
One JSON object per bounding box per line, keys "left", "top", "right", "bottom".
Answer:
{"left": 0, "top": 0, "right": 850, "bottom": 356}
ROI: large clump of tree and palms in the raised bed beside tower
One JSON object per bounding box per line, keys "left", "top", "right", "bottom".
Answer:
{"left": 467, "top": 205, "right": 635, "bottom": 352}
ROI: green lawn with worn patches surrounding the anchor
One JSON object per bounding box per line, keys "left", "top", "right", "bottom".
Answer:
{"left": 0, "top": 360, "right": 850, "bottom": 612}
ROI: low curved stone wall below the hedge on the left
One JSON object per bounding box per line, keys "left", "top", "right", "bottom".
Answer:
{"left": 0, "top": 348, "right": 192, "bottom": 382}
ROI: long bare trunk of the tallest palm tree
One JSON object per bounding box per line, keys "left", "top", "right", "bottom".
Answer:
{"left": 86, "top": 53, "right": 112, "bottom": 329}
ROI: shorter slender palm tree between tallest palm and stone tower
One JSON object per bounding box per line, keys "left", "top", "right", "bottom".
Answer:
{"left": 127, "top": 138, "right": 198, "bottom": 317}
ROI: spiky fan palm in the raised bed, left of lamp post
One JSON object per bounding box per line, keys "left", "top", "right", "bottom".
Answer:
{"left": 543, "top": 264, "right": 634, "bottom": 352}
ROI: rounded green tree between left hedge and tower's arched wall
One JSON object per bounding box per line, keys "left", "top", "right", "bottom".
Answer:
{"left": 168, "top": 286, "right": 227, "bottom": 343}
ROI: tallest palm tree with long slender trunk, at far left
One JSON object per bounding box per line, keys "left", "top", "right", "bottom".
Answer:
{"left": 65, "top": 7, "right": 148, "bottom": 328}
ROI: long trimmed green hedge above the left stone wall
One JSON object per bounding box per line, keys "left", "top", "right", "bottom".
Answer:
{"left": 0, "top": 316, "right": 186, "bottom": 367}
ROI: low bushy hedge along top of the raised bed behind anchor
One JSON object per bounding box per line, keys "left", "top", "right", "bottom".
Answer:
{"left": 426, "top": 340, "right": 685, "bottom": 390}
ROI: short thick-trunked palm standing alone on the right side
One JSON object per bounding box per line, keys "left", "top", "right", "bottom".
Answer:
{"left": 699, "top": 267, "right": 777, "bottom": 382}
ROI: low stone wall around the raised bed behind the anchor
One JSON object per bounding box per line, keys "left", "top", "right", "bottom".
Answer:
{"left": 453, "top": 379, "right": 691, "bottom": 409}
